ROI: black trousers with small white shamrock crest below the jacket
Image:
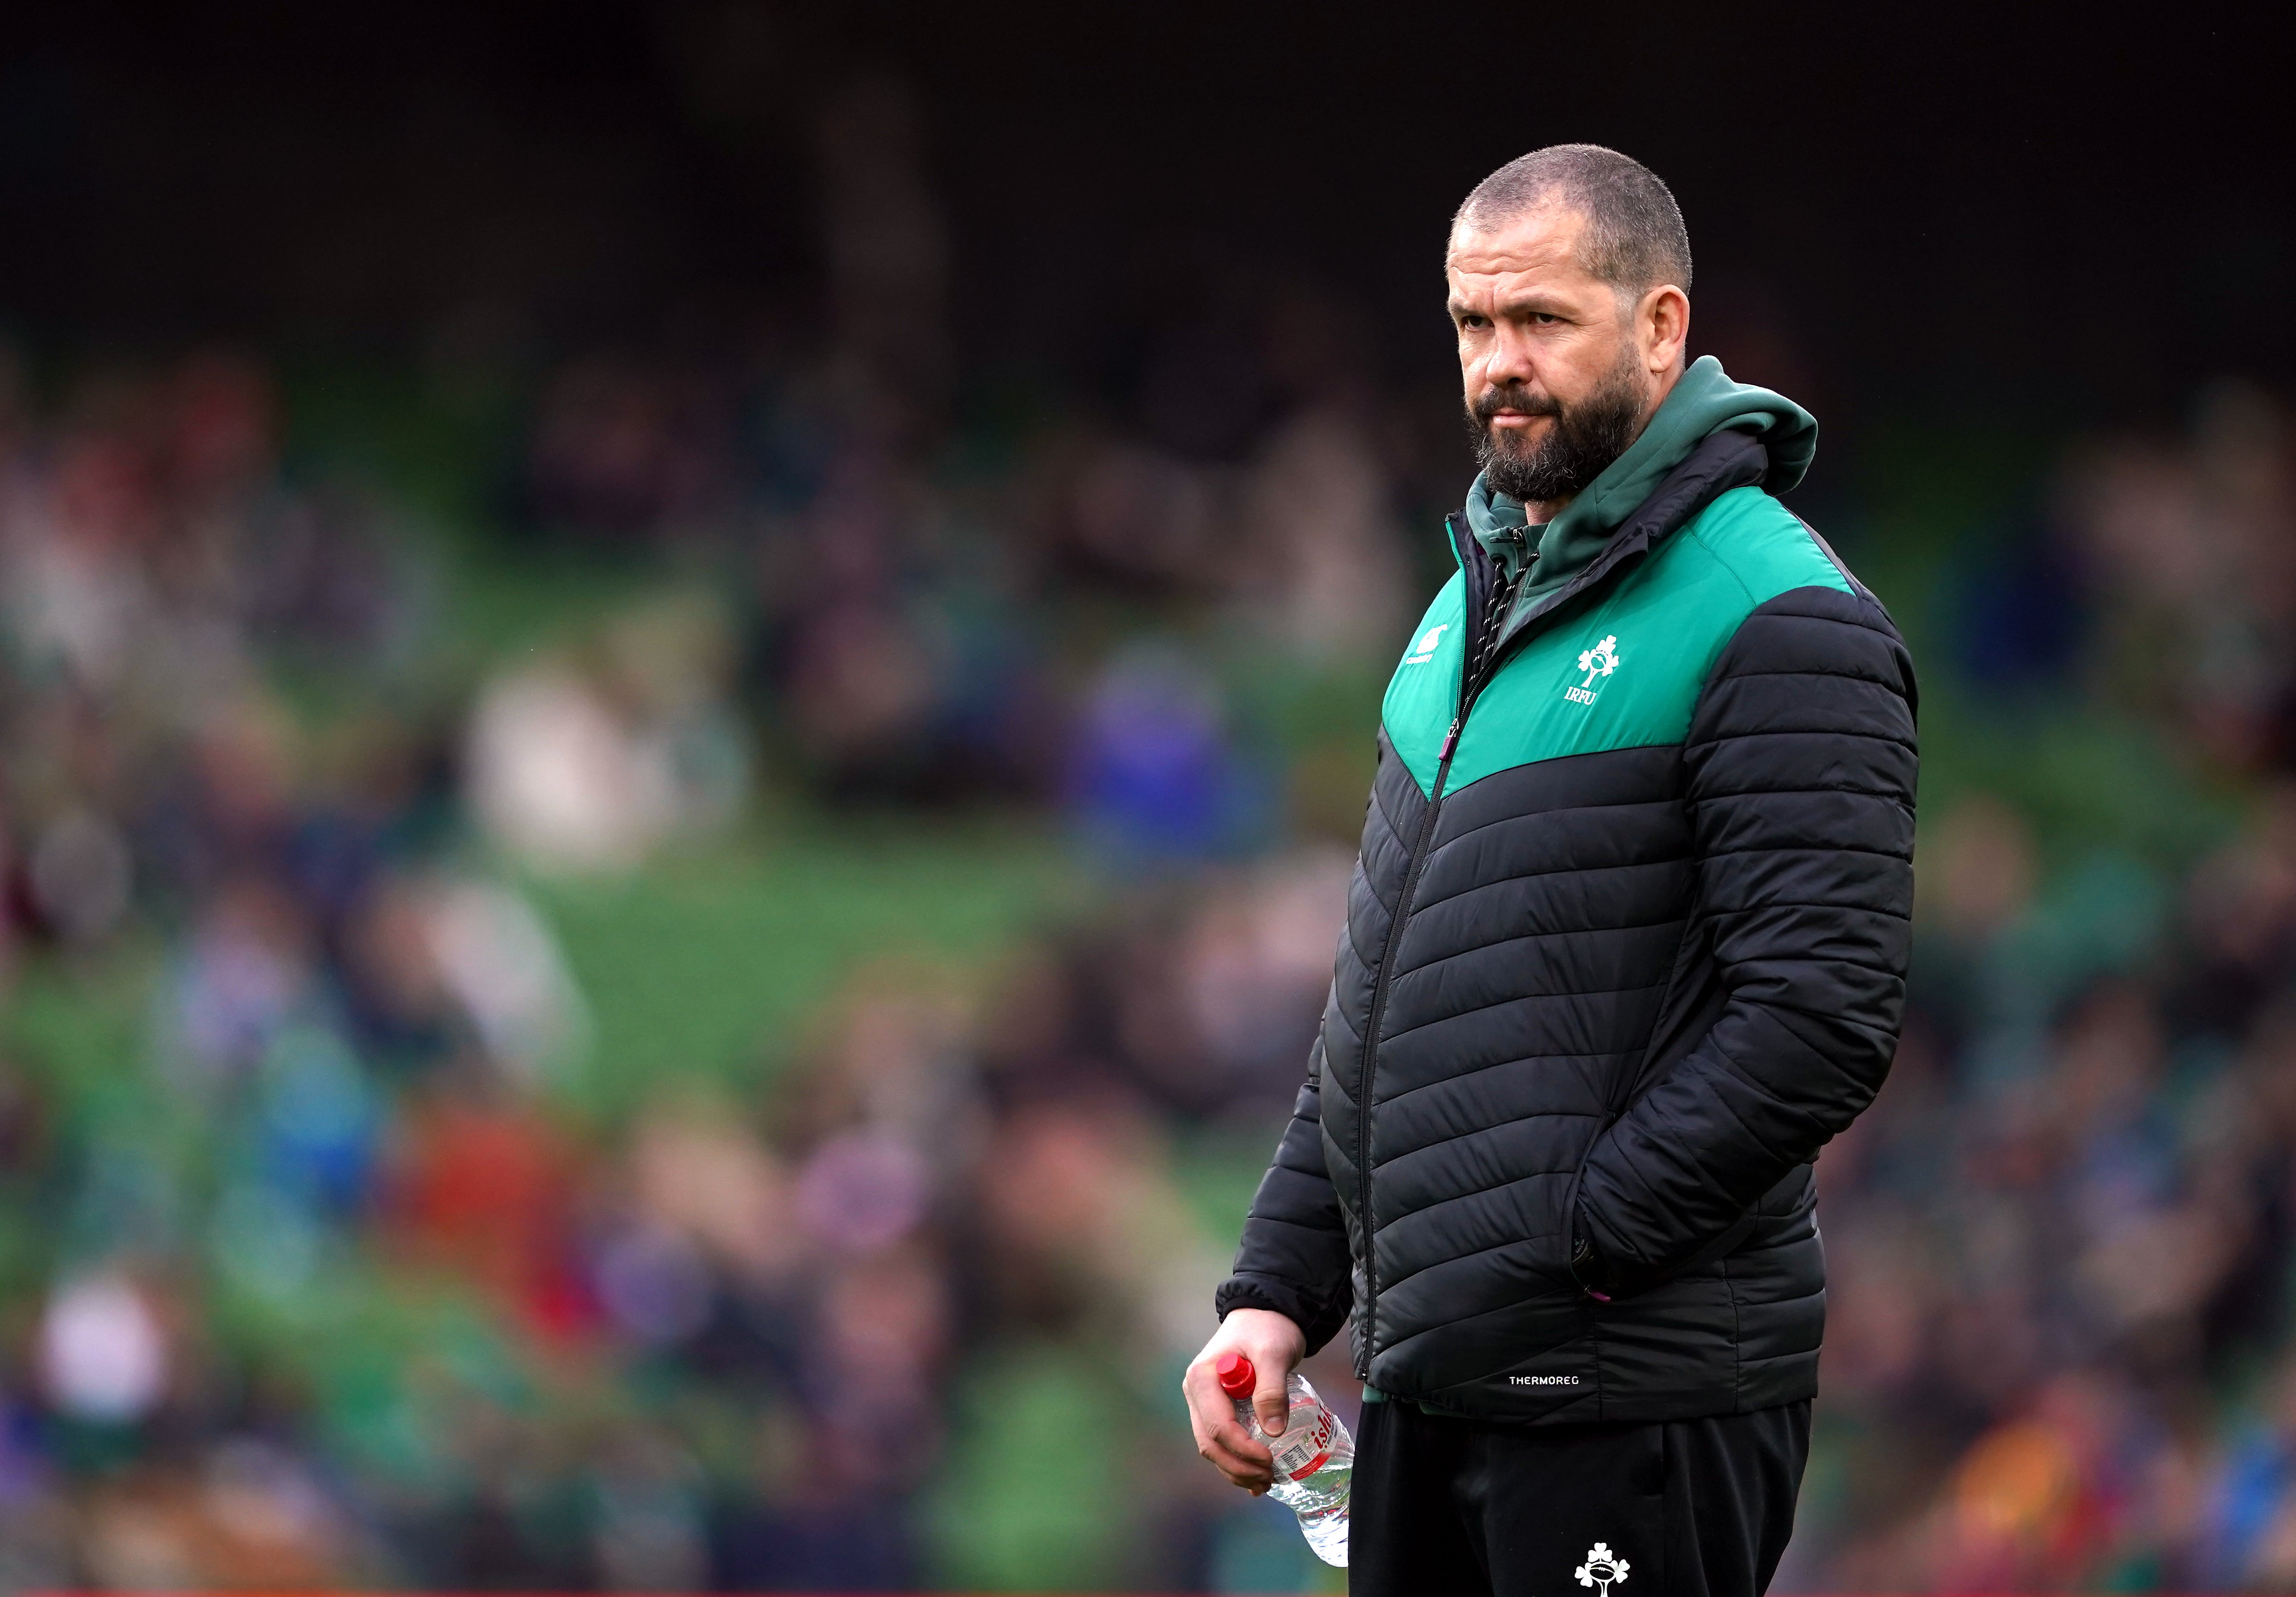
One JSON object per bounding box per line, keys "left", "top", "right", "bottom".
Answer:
{"left": 1348, "top": 1402, "right": 1809, "bottom": 1597}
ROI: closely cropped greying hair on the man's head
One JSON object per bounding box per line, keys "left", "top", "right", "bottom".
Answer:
{"left": 1451, "top": 145, "right": 1690, "bottom": 294}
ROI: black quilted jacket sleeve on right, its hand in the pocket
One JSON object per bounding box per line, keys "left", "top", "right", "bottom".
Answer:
{"left": 1575, "top": 588, "right": 1917, "bottom": 1291}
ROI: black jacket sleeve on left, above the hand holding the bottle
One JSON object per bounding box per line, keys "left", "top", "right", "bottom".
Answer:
{"left": 1214, "top": 1041, "right": 1352, "bottom": 1353}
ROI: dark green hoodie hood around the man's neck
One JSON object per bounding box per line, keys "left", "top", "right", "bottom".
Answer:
{"left": 1467, "top": 354, "right": 1819, "bottom": 604}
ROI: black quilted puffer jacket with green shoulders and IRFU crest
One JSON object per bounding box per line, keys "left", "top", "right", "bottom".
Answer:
{"left": 1217, "top": 432, "right": 1915, "bottom": 1420}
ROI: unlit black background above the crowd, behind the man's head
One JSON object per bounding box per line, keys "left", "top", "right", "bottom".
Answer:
{"left": 0, "top": 2, "right": 2296, "bottom": 427}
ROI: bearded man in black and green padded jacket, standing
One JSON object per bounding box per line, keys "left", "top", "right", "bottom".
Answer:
{"left": 1185, "top": 145, "right": 1915, "bottom": 1597}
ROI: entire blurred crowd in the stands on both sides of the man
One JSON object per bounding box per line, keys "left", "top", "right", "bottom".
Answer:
{"left": 0, "top": 203, "right": 2296, "bottom": 1590}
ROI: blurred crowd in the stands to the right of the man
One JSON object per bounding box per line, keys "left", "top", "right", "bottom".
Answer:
{"left": 1784, "top": 386, "right": 2296, "bottom": 1590}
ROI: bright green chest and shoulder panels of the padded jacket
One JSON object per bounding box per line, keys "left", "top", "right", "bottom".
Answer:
{"left": 1382, "top": 487, "right": 1851, "bottom": 793}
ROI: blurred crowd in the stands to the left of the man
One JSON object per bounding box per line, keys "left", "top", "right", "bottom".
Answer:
{"left": 0, "top": 281, "right": 1407, "bottom": 1590}
